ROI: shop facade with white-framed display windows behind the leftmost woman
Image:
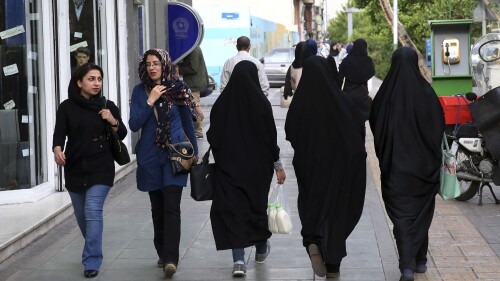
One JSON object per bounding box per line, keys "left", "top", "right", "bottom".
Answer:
{"left": 0, "top": 0, "right": 167, "bottom": 205}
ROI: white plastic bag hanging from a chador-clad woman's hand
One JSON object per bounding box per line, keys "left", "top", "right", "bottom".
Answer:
{"left": 267, "top": 184, "right": 293, "bottom": 234}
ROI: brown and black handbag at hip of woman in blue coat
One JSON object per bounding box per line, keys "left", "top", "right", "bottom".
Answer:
{"left": 167, "top": 141, "right": 194, "bottom": 176}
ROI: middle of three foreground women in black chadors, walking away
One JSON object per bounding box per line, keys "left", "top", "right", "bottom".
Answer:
{"left": 285, "top": 56, "right": 366, "bottom": 278}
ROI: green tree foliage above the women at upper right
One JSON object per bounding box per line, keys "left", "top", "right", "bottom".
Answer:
{"left": 328, "top": 0, "right": 480, "bottom": 78}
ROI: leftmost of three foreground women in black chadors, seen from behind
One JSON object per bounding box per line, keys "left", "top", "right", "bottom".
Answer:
{"left": 207, "top": 60, "right": 285, "bottom": 277}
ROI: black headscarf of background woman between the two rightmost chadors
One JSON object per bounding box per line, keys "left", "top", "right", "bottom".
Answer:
{"left": 339, "top": 39, "right": 375, "bottom": 84}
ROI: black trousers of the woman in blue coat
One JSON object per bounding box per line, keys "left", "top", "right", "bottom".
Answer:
{"left": 149, "top": 185, "right": 182, "bottom": 265}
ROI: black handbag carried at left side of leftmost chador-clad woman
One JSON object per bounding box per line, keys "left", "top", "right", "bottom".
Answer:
{"left": 189, "top": 148, "right": 215, "bottom": 201}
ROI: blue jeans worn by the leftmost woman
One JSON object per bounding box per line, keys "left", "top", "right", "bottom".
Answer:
{"left": 68, "top": 184, "right": 111, "bottom": 270}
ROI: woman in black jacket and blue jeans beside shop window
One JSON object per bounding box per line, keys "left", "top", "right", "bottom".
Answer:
{"left": 52, "top": 63, "right": 127, "bottom": 278}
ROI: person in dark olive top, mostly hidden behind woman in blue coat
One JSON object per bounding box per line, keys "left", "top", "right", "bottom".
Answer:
{"left": 177, "top": 46, "right": 208, "bottom": 139}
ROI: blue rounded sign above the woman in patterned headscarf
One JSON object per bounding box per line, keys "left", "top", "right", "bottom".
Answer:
{"left": 167, "top": 2, "right": 203, "bottom": 63}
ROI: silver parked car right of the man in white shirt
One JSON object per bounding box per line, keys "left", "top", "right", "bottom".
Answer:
{"left": 260, "top": 47, "right": 295, "bottom": 87}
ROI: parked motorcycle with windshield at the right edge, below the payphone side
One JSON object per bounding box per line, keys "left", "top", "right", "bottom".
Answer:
{"left": 448, "top": 33, "right": 500, "bottom": 205}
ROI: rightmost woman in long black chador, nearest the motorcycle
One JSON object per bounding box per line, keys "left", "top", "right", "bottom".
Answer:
{"left": 370, "top": 47, "right": 444, "bottom": 280}
